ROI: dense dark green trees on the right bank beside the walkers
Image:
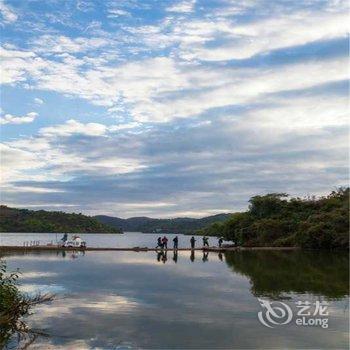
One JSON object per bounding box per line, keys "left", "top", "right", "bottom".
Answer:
{"left": 197, "top": 188, "right": 349, "bottom": 249}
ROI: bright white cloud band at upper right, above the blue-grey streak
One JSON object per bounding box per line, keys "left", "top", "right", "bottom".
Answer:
{"left": 176, "top": 11, "right": 349, "bottom": 61}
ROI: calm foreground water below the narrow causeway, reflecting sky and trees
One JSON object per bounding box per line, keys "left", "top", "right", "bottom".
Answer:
{"left": 4, "top": 234, "right": 349, "bottom": 349}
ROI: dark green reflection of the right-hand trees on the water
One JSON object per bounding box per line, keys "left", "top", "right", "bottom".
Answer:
{"left": 225, "top": 250, "right": 349, "bottom": 299}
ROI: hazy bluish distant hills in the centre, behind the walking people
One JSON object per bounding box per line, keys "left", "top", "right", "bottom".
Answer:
{"left": 95, "top": 214, "right": 231, "bottom": 233}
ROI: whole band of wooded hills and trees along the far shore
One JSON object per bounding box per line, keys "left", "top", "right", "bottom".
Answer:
{"left": 0, "top": 188, "right": 349, "bottom": 249}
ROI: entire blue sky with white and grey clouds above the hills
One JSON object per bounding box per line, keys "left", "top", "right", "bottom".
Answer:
{"left": 0, "top": 0, "right": 350, "bottom": 218}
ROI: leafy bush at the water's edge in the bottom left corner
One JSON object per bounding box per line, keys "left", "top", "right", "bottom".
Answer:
{"left": 0, "top": 260, "right": 53, "bottom": 349}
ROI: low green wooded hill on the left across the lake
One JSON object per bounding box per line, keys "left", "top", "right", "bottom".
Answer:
{"left": 0, "top": 205, "right": 121, "bottom": 233}
